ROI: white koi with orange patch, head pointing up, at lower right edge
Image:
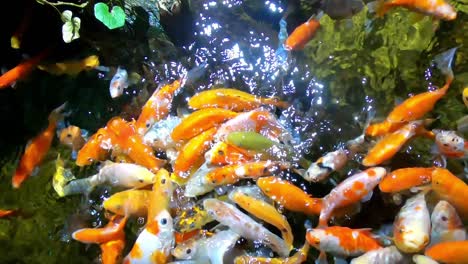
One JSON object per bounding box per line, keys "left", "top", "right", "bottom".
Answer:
{"left": 429, "top": 200, "right": 466, "bottom": 246}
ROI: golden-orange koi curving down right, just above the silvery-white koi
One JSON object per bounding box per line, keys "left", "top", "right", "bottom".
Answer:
{"left": 229, "top": 191, "right": 294, "bottom": 249}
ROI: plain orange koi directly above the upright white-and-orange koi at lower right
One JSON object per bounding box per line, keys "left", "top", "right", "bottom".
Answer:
{"left": 379, "top": 167, "right": 436, "bottom": 193}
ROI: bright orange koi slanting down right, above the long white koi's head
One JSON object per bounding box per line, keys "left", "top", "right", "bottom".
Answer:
{"left": 107, "top": 117, "right": 165, "bottom": 172}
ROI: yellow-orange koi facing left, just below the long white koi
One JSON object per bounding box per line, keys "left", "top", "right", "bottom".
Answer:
{"left": 102, "top": 190, "right": 151, "bottom": 217}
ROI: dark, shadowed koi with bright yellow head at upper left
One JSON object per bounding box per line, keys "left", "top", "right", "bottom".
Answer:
{"left": 37, "top": 55, "right": 99, "bottom": 76}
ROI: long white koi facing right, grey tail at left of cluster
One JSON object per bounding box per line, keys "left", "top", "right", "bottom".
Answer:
{"left": 59, "top": 161, "right": 155, "bottom": 195}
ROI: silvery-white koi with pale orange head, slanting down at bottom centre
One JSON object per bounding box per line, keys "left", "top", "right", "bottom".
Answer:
{"left": 203, "top": 198, "right": 290, "bottom": 257}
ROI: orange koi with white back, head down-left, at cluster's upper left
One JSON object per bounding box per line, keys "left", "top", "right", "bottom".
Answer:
{"left": 135, "top": 80, "right": 181, "bottom": 135}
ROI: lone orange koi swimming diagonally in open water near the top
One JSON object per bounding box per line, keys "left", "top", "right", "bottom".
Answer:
{"left": 284, "top": 17, "right": 320, "bottom": 50}
